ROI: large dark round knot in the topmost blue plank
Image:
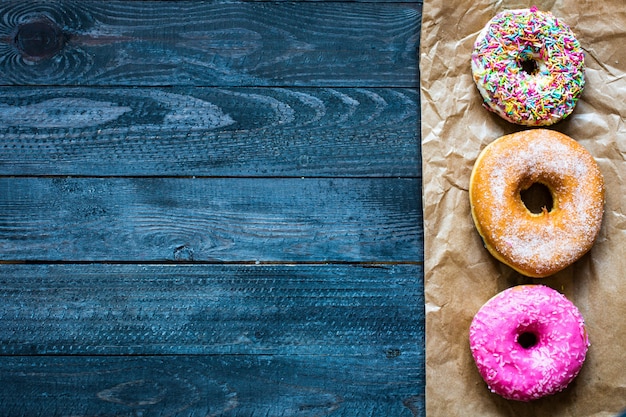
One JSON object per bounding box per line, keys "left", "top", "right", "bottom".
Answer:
{"left": 14, "top": 18, "right": 67, "bottom": 61}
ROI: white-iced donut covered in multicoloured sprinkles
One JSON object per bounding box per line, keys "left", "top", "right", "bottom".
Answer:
{"left": 471, "top": 7, "right": 585, "bottom": 126}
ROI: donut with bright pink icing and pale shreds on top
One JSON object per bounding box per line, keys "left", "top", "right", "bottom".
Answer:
{"left": 469, "top": 285, "right": 589, "bottom": 401}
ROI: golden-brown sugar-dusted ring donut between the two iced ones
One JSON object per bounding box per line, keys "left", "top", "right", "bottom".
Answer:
{"left": 469, "top": 128, "right": 604, "bottom": 278}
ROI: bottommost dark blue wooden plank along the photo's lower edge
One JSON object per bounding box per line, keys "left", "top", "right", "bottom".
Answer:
{"left": 0, "top": 354, "right": 425, "bottom": 417}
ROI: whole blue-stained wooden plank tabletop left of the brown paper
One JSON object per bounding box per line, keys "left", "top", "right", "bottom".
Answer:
{"left": 0, "top": 1, "right": 425, "bottom": 417}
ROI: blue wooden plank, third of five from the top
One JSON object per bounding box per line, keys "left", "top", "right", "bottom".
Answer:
{"left": 0, "top": 177, "right": 423, "bottom": 262}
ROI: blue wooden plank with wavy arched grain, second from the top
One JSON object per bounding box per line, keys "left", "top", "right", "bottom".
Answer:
{"left": 0, "top": 87, "right": 421, "bottom": 177}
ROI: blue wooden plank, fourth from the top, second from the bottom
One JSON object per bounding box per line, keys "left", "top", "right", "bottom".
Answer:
{"left": 0, "top": 264, "right": 424, "bottom": 358}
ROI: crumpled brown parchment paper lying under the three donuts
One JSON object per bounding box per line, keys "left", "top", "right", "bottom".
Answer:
{"left": 420, "top": 0, "right": 626, "bottom": 417}
